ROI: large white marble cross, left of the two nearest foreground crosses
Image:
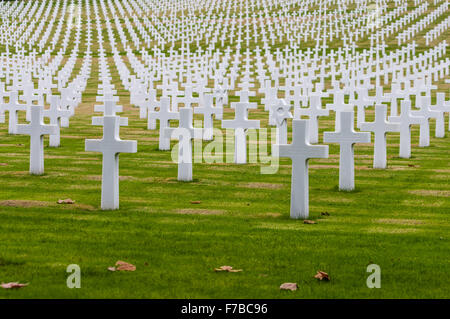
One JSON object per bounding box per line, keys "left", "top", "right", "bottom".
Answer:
{"left": 85, "top": 115, "right": 137, "bottom": 210}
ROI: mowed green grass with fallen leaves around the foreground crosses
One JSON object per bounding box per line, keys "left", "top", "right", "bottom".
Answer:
{"left": 0, "top": 73, "right": 450, "bottom": 298}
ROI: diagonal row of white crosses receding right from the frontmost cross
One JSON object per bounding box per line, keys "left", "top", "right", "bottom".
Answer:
{"left": 270, "top": 79, "right": 450, "bottom": 218}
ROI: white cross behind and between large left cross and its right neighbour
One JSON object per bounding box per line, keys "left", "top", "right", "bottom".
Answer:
{"left": 148, "top": 97, "right": 180, "bottom": 151}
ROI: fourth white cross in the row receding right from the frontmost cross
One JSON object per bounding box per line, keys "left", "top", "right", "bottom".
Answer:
{"left": 389, "top": 100, "right": 426, "bottom": 158}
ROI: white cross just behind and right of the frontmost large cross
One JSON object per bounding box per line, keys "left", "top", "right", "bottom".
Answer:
{"left": 323, "top": 111, "right": 371, "bottom": 191}
